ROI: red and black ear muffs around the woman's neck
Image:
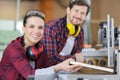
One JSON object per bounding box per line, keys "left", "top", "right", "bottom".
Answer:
{"left": 26, "top": 45, "right": 43, "bottom": 61}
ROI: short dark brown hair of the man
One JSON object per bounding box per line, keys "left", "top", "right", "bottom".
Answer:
{"left": 69, "top": 0, "right": 90, "bottom": 15}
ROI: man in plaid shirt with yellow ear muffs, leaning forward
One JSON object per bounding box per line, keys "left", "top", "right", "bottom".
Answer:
{"left": 43, "top": 0, "right": 90, "bottom": 65}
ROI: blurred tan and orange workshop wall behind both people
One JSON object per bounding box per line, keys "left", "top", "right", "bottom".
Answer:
{"left": 0, "top": 0, "right": 120, "bottom": 47}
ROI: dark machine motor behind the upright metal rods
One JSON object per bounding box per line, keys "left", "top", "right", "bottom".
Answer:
{"left": 97, "top": 21, "right": 120, "bottom": 47}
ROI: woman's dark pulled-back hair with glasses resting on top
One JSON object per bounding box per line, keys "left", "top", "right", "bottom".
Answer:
{"left": 23, "top": 10, "right": 45, "bottom": 26}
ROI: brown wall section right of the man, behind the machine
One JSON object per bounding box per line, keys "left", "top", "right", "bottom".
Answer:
{"left": 91, "top": 0, "right": 120, "bottom": 47}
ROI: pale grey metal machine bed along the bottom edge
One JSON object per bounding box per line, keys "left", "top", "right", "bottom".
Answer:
{"left": 58, "top": 74, "right": 120, "bottom": 80}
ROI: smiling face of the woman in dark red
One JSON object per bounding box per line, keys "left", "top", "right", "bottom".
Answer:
{"left": 23, "top": 16, "right": 44, "bottom": 46}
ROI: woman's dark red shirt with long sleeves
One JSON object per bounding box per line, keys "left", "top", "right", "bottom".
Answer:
{"left": 0, "top": 37, "right": 47, "bottom": 80}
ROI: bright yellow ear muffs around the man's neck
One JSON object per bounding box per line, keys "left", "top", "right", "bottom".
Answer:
{"left": 67, "top": 23, "right": 80, "bottom": 37}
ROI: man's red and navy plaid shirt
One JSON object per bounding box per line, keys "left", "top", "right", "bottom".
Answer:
{"left": 43, "top": 17, "right": 84, "bottom": 65}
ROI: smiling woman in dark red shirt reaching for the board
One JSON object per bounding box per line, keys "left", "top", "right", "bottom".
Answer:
{"left": 0, "top": 10, "right": 80, "bottom": 80}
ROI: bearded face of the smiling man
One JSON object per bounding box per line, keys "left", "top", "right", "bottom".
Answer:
{"left": 67, "top": 5, "right": 88, "bottom": 25}
